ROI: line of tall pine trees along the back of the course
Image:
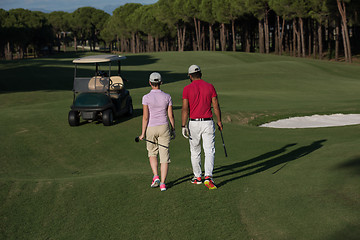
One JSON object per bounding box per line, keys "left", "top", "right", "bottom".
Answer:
{"left": 0, "top": 0, "right": 360, "bottom": 62}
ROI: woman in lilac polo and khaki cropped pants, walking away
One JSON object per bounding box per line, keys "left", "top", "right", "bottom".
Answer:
{"left": 139, "top": 72, "right": 175, "bottom": 191}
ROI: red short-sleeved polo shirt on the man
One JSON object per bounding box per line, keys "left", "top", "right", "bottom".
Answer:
{"left": 182, "top": 79, "right": 217, "bottom": 118}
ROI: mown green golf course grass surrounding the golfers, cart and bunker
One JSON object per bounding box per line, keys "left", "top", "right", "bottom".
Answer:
{"left": 0, "top": 52, "right": 360, "bottom": 240}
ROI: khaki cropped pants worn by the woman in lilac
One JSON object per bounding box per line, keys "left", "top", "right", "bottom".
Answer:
{"left": 146, "top": 124, "right": 171, "bottom": 163}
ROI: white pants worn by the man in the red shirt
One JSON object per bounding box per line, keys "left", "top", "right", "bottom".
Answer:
{"left": 189, "top": 120, "right": 215, "bottom": 177}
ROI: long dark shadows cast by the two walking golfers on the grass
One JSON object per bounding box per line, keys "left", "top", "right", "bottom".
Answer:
{"left": 168, "top": 139, "right": 327, "bottom": 188}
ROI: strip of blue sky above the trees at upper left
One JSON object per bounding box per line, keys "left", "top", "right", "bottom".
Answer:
{"left": 0, "top": 0, "right": 157, "bottom": 14}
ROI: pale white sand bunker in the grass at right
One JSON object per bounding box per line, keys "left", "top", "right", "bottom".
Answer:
{"left": 260, "top": 113, "right": 360, "bottom": 128}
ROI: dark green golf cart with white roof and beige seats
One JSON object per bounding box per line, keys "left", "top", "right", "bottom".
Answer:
{"left": 68, "top": 55, "right": 133, "bottom": 126}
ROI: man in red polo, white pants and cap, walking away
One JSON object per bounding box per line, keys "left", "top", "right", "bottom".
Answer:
{"left": 181, "top": 65, "right": 223, "bottom": 189}
